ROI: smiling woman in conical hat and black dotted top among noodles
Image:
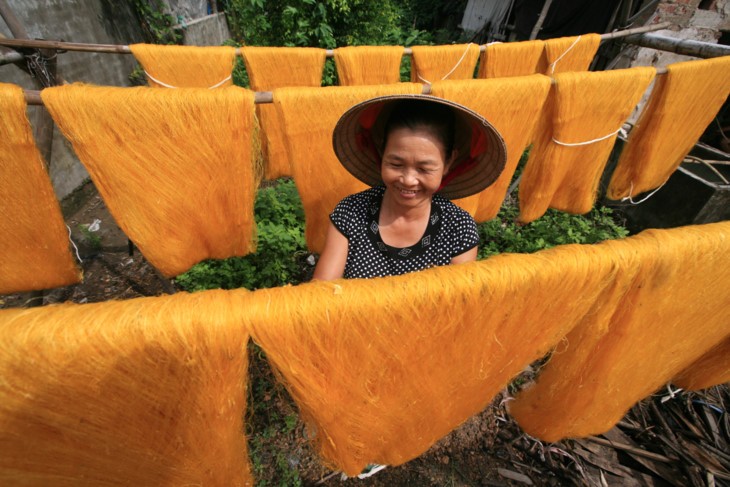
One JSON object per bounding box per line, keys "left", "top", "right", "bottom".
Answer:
{"left": 314, "top": 95, "right": 505, "bottom": 280}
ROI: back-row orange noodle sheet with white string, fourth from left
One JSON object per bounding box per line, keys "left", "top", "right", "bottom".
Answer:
{"left": 411, "top": 43, "right": 479, "bottom": 84}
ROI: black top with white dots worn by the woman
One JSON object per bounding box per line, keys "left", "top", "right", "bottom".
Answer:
{"left": 330, "top": 186, "right": 479, "bottom": 279}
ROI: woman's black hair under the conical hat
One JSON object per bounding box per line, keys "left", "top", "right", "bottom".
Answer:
{"left": 383, "top": 100, "right": 455, "bottom": 158}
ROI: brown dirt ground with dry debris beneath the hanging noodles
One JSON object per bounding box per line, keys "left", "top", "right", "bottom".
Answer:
{"left": 0, "top": 184, "right": 730, "bottom": 486}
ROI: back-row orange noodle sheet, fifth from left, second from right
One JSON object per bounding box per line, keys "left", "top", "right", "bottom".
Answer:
{"left": 477, "top": 41, "right": 545, "bottom": 78}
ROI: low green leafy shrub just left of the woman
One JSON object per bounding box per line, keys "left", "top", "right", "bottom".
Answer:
{"left": 175, "top": 180, "right": 306, "bottom": 291}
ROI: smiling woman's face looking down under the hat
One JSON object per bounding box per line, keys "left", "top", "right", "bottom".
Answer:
{"left": 380, "top": 127, "right": 453, "bottom": 207}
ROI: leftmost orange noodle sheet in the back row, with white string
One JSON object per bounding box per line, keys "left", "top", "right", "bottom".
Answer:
{"left": 129, "top": 44, "right": 236, "bottom": 88}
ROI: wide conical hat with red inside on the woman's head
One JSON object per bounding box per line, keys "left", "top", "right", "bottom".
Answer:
{"left": 332, "top": 95, "right": 507, "bottom": 199}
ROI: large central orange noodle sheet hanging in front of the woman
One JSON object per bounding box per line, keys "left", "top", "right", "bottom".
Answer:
{"left": 246, "top": 245, "right": 613, "bottom": 476}
